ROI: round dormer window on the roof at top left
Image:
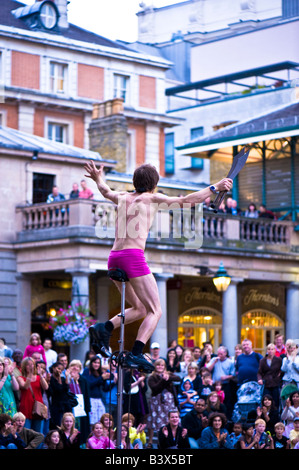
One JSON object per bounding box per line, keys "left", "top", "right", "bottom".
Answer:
{"left": 12, "top": 0, "right": 59, "bottom": 31}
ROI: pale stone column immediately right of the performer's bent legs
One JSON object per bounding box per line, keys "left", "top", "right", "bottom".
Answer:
{"left": 150, "top": 273, "right": 173, "bottom": 357}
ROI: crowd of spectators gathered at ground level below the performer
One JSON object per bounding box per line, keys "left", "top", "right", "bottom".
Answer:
{"left": 0, "top": 333, "right": 299, "bottom": 449}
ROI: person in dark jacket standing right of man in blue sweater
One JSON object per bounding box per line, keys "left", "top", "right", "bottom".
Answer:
{"left": 257, "top": 343, "right": 282, "bottom": 408}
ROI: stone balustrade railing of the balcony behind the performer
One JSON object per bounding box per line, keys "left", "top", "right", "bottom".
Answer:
{"left": 16, "top": 199, "right": 299, "bottom": 251}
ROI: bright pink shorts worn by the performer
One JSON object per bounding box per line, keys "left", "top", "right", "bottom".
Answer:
{"left": 108, "top": 248, "right": 151, "bottom": 279}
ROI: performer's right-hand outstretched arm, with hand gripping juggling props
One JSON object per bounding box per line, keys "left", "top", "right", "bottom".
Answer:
{"left": 154, "top": 178, "right": 233, "bottom": 207}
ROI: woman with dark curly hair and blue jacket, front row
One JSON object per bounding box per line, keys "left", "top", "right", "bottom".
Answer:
{"left": 199, "top": 412, "right": 233, "bottom": 449}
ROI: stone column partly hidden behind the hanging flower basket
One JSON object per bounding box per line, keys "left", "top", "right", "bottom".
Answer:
{"left": 67, "top": 269, "right": 95, "bottom": 364}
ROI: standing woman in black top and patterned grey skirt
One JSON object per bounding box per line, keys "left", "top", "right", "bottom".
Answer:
{"left": 147, "top": 359, "right": 180, "bottom": 448}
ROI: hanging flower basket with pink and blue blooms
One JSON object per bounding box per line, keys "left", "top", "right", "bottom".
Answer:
{"left": 49, "top": 304, "right": 95, "bottom": 344}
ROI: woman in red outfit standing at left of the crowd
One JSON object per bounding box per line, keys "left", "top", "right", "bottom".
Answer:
{"left": 18, "top": 357, "right": 48, "bottom": 432}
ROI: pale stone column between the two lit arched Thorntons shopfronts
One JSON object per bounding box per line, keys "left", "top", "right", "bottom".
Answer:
{"left": 222, "top": 278, "right": 243, "bottom": 355}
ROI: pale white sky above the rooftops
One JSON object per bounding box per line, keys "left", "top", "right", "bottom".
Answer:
{"left": 20, "top": 0, "right": 184, "bottom": 42}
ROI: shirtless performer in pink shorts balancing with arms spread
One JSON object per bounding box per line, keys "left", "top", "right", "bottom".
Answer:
{"left": 84, "top": 161, "right": 232, "bottom": 369}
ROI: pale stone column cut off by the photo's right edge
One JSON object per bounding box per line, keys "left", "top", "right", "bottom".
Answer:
{"left": 285, "top": 282, "right": 299, "bottom": 339}
